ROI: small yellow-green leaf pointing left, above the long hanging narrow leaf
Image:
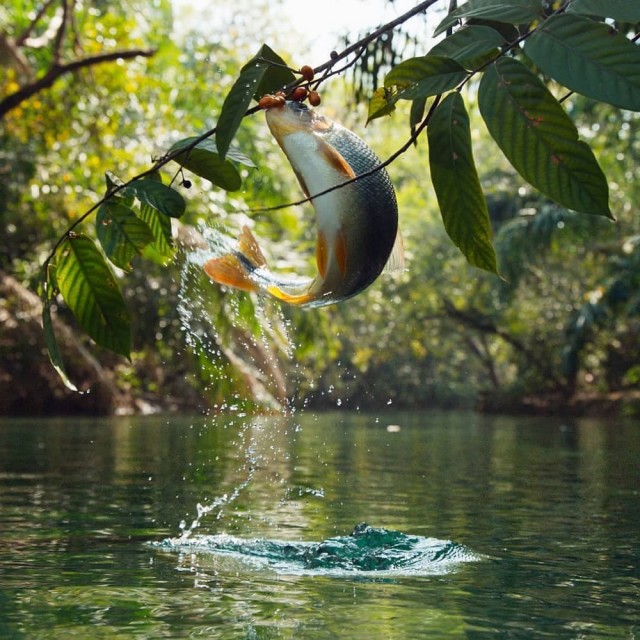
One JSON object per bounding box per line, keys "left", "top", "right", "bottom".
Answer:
{"left": 384, "top": 56, "right": 467, "bottom": 100}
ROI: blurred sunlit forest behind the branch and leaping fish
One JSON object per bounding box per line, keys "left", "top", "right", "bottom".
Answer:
{"left": 0, "top": 0, "right": 640, "bottom": 414}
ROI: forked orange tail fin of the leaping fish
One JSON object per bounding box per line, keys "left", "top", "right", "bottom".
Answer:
{"left": 203, "top": 226, "right": 267, "bottom": 291}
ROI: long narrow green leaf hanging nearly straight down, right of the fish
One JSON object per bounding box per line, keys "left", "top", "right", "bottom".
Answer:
{"left": 427, "top": 92, "right": 498, "bottom": 273}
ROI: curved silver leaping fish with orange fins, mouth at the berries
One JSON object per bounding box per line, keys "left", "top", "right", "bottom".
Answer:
{"left": 204, "top": 101, "right": 401, "bottom": 307}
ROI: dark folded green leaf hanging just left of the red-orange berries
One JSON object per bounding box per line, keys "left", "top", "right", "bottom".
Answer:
{"left": 216, "top": 44, "right": 295, "bottom": 158}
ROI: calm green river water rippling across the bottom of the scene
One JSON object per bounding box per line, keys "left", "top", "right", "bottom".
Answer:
{"left": 0, "top": 412, "right": 640, "bottom": 640}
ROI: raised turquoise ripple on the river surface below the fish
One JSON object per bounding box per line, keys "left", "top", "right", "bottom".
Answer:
{"left": 153, "top": 523, "right": 481, "bottom": 576}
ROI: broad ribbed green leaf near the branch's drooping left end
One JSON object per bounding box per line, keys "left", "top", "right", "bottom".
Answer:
{"left": 56, "top": 235, "right": 131, "bottom": 358}
